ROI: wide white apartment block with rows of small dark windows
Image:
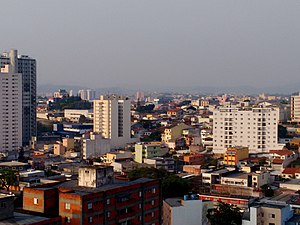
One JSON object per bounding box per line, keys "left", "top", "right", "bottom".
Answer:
{"left": 213, "top": 107, "right": 279, "bottom": 154}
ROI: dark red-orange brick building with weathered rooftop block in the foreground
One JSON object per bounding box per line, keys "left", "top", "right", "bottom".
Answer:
{"left": 23, "top": 166, "right": 162, "bottom": 225}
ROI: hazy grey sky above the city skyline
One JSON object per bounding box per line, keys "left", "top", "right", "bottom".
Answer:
{"left": 0, "top": 0, "right": 300, "bottom": 88}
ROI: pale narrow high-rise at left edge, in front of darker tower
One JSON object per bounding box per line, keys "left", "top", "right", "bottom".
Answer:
{"left": 0, "top": 65, "right": 22, "bottom": 154}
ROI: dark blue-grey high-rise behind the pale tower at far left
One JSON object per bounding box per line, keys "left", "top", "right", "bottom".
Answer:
{"left": 0, "top": 50, "right": 36, "bottom": 146}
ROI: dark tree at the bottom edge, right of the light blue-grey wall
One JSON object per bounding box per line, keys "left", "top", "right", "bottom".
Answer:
{"left": 206, "top": 201, "right": 243, "bottom": 225}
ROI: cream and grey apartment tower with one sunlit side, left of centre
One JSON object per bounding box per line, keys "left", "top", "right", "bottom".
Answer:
{"left": 94, "top": 95, "right": 131, "bottom": 148}
